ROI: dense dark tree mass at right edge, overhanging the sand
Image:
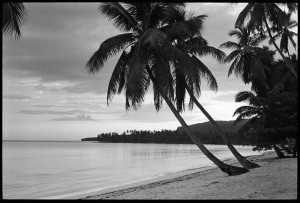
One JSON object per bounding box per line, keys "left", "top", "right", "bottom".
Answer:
{"left": 234, "top": 52, "right": 297, "bottom": 157}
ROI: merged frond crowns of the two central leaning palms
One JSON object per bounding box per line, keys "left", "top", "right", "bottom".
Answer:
{"left": 87, "top": 3, "right": 224, "bottom": 110}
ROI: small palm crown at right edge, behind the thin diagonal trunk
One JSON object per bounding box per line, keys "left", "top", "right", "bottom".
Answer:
{"left": 269, "top": 12, "right": 298, "bottom": 58}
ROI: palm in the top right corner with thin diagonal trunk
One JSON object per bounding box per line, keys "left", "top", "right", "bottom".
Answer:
{"left": 235, "top": 2, "right": 298, "bottom": 78}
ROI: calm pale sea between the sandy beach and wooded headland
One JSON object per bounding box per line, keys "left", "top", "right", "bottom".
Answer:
{"left": 2, "top": 141, "right": 260, "bottom": 199}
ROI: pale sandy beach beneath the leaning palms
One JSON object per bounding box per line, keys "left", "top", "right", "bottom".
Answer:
{"left": 76, "top": 151, "right": 298, "bottom": 199}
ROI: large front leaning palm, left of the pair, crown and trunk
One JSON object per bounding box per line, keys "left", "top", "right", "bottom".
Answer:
{"left": 87, "top": 2, "right": 248, "bottom": 175}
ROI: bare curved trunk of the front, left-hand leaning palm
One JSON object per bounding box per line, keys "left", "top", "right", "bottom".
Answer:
{"left": 147, "top": 67, "right": 248, "bottom": 176}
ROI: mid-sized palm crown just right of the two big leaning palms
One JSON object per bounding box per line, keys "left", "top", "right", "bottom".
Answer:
{"left": 220, "top": 26, "right": 266, "bottom": 84}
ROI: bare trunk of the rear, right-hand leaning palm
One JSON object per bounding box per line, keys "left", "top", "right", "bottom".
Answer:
{"left": 185, "top": 86, "right": 260, "bottom": 169}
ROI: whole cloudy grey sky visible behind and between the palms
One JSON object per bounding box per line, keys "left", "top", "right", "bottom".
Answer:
{"left": 2, "top": 3, "right": 298, "bottom": 140}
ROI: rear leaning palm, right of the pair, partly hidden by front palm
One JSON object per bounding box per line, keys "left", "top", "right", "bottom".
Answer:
{"left": 162, "top": 10, "right": 259, "bottom": 169}
